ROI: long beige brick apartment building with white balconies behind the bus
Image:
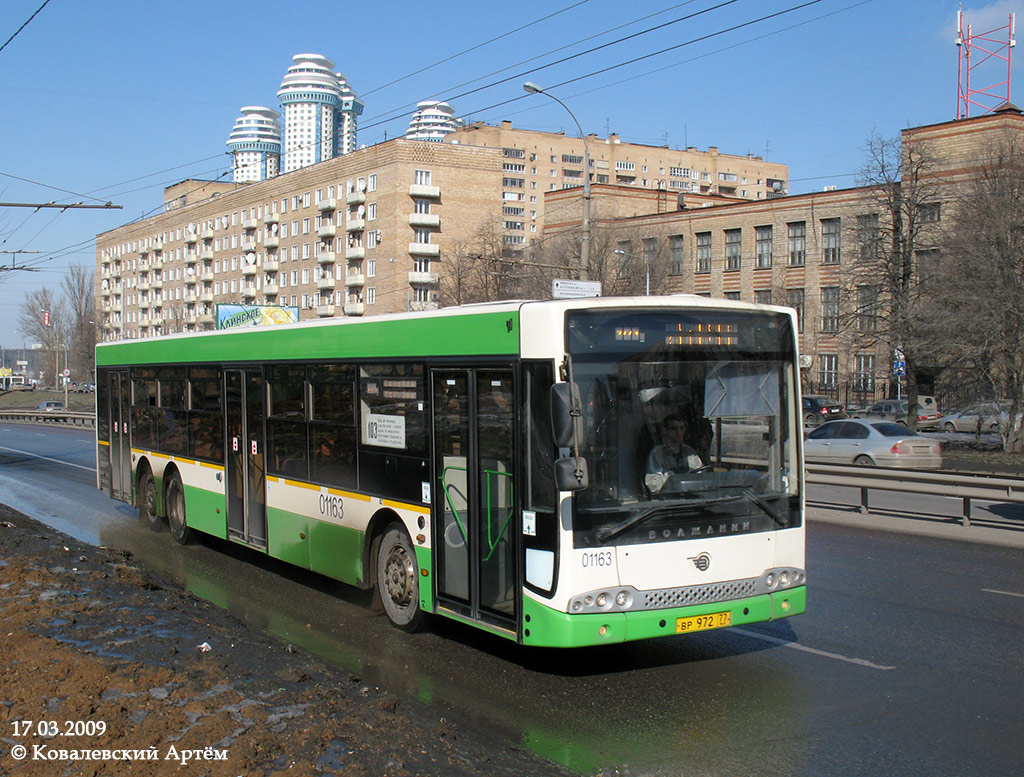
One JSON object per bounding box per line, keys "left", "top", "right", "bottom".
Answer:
{"left": 96, "top": 138, "right": 502, "bottom": 340}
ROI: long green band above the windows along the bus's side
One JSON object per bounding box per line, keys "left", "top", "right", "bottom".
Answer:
{"left": 96, "top": 310, "right": 519, "bottom": 366}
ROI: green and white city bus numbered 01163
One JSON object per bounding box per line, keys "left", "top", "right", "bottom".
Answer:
{"left": 96, "top": 296, "right": 806, "bottom": 647}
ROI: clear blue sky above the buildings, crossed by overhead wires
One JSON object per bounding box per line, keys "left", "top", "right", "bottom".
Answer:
{"left": 0, "top": 0, "right": 1024, "bottom": 347}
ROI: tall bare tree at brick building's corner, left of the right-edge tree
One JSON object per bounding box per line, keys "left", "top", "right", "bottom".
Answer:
{"left": 843, "top": 135, "right": 942, "bottom": 429}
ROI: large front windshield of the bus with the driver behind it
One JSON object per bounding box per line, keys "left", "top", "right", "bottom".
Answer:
{"left": 568, "top": 310, "right": 801, "bottom": 547}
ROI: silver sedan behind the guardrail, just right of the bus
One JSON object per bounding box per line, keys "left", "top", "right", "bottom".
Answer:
{"left": 804, "top": 419, "right": 942, "bottom": 470}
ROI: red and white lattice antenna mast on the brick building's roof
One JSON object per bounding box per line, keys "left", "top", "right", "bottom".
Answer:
{"left": 956, "top": 9, "right": 1017, "bottom": 119}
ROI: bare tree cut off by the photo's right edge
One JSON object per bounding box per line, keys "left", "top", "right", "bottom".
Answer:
{"left": 929, "top": 138, "right": 1024, "bottom": 452}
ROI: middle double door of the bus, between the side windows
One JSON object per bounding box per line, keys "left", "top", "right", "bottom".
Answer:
{"left": 224, "top": 369, "right": 266, "bottom": 549}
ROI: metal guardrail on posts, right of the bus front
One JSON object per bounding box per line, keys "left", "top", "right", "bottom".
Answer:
{"left": 806, "top": 464, "right": 1024, "bottom": 526}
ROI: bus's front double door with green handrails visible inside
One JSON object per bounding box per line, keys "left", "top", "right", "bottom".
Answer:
{"left": 433, "top": 369, "right": 518, "bottom": 628}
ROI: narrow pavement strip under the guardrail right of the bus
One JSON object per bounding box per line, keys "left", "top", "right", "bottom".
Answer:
{"left": 807, "top": 500, "right": 1024, "bottom": 548}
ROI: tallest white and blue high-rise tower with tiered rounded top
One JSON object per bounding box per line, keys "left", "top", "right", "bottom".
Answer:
{"left": 278, "top": 54, "right": 362, "bottom": 173}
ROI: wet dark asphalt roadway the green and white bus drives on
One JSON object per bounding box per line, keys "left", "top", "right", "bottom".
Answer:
{"left": 0, "top": 425, "right": 1024, "bottom": 777}
